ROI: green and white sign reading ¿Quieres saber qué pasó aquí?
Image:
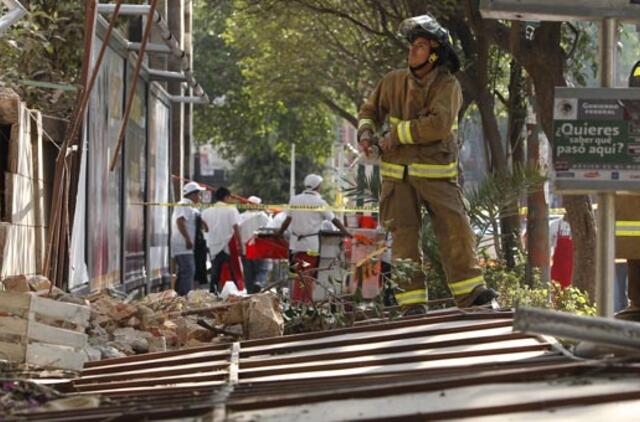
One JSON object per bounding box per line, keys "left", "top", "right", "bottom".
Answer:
{"left": 553, "top": 88, "right": 640, "bottom": 193}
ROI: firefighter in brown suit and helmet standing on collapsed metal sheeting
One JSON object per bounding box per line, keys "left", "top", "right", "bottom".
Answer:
{"left": 358, "top": 15, "right": 497, "bottom": 315}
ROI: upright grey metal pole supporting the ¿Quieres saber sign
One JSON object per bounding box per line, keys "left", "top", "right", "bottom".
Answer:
{"left": 596, "top": 18, "right": 617, "bottom": 317}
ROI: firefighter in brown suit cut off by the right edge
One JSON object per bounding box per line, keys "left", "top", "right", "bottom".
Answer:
{"left": 616, "top": 62, "right": 640, "bottom": 322}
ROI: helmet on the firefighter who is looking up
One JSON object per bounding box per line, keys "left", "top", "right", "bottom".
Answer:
{"left": 398, "top": 15, "right": 460, "bottom": 73}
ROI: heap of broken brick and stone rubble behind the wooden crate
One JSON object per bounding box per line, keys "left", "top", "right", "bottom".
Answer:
{"left": 0, "top": 276, "right": 284, "bottom": 361}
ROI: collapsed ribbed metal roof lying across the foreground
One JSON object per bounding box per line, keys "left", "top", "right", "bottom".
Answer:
{"left": 11, "top": 309, "right": 640, "bottom": 422}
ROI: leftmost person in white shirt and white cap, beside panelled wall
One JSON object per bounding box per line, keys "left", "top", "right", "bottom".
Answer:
{"left": 171, "top": 182, "right": 207, "bottom": 296}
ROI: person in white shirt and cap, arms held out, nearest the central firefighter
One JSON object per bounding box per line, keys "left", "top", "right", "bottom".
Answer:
{"left": 276, "top": 174, "right": 351, "bottom": 302}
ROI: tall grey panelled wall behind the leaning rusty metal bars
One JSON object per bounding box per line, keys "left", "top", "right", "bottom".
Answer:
{"left": 79, "top": 18, "right": 171, "bottom": 291}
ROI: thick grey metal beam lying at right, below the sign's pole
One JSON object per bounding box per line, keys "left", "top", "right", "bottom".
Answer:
{"left": 513, "top": 307, "right": 640, "bottom": 350}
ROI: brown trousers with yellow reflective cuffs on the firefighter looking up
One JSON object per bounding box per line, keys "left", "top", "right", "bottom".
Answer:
{"left": 380, "top": 174, "right": 486, "bottom": 307}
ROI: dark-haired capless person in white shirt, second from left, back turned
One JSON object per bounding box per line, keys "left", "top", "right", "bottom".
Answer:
{"left": 202, "top": 186, "right": 244, "bottom": 292}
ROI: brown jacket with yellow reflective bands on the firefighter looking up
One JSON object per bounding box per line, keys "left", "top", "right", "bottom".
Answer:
{"left": 358, "top": 67, "right": 462, "bottom": 179}
